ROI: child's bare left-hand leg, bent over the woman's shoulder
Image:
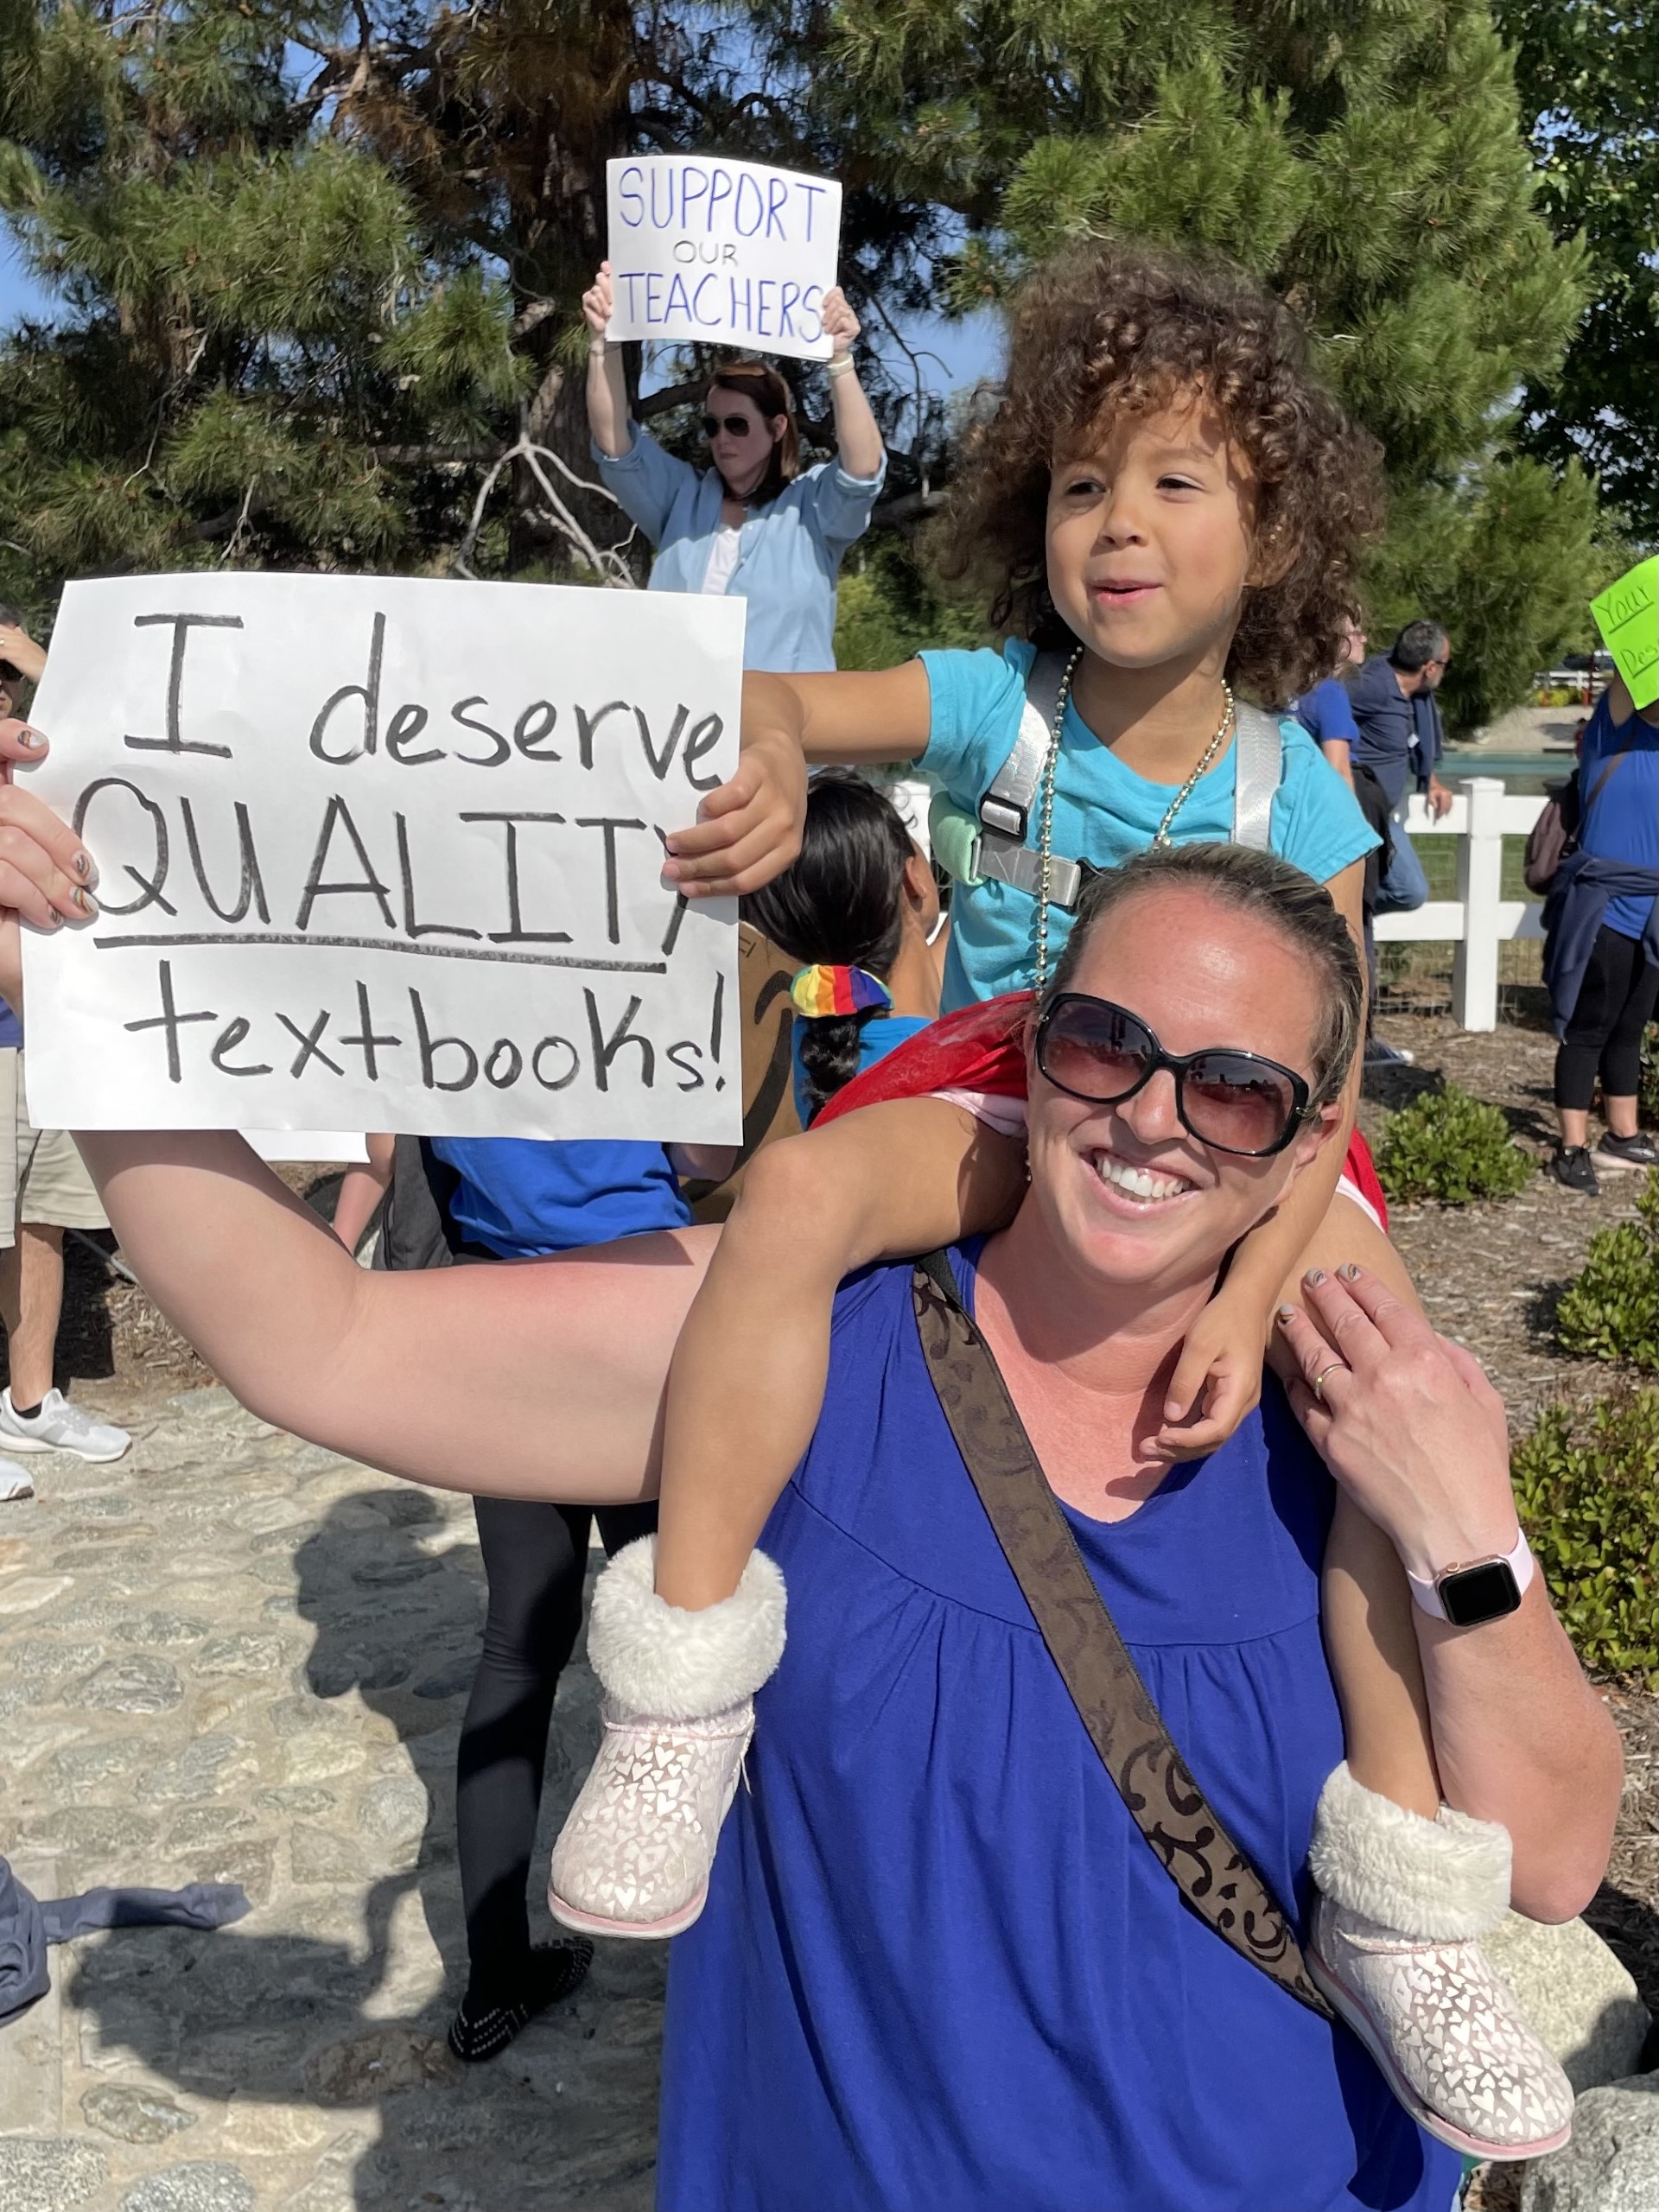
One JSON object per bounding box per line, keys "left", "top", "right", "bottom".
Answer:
{"left": 657, "top": 1097, "right": 1024, "bottom": 1611}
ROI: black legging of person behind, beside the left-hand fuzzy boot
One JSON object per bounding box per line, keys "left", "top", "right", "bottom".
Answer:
{"left": 455, "top": 1497, "right": 657, "bottom": 2004}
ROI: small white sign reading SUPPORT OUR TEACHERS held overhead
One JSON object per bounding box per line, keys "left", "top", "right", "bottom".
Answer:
{"left": 606, "top": 153, "right": 841, "bottom": 360}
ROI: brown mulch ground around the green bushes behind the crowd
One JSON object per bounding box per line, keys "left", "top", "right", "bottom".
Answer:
{"left": 22, "top": 1035, "right": 1659, "bottom": 2035}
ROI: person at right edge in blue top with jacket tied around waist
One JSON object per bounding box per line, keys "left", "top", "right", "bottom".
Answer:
{"left": 1544, "top": 677, "right": 1659, "bottom": 1199}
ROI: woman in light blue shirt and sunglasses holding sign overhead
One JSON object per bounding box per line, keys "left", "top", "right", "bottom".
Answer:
{"left": 582, "top": 261, "right": 887, "bottom": 672}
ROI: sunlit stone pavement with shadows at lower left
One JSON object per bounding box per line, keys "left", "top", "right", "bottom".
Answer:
{"left": 0, "top": 1389, "right": 664, "bottom": 2212}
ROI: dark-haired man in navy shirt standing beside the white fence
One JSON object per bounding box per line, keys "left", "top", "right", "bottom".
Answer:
{"left": 1344, "top": 621, "right": 1451, "bottom": 1066}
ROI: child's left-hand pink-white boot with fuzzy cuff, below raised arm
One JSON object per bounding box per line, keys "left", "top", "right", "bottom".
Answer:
{"left": 546, "top": 1535, "right": 783, "bottom": 1938}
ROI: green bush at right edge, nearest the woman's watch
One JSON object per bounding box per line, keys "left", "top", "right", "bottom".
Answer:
{"left": 1510, "top": 1382, "right": 1659, "bottom": 1679}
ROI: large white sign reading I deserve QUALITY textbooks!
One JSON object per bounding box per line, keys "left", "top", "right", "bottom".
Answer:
{"left": 24, "top": 575, "right": 743, "bottom": 1144}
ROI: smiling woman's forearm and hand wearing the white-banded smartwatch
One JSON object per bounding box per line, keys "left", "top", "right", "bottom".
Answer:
{"left": 1279, "top": 1269, "right": 1621, "bottom": 1920}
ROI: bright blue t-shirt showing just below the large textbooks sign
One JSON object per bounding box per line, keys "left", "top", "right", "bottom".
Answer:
{"left": 431, "top": 1137, "right": 690, "bottom": 1259}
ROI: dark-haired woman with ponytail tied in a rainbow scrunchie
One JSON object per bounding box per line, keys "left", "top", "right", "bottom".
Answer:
{"left": 743, "top": 774, "right": 940, "bottom": 1128}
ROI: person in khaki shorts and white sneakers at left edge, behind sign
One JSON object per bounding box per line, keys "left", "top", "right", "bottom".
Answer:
{"left": 0, "top": 604, "right": 130, "bottom": 1502}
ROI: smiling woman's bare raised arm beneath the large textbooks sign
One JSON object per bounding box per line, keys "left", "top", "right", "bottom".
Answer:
{"left": 75, "top": 1130, "right": 716, "bottom": 1504}
